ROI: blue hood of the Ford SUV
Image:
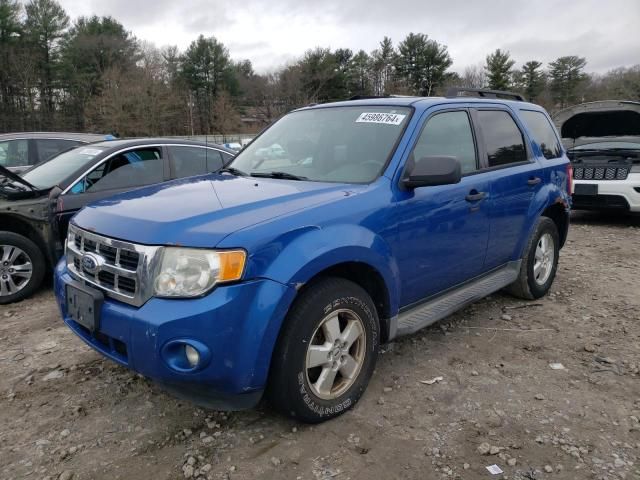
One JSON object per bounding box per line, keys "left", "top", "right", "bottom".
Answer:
{"left": 73, "top": 175, "right": 364, "bottom": 247}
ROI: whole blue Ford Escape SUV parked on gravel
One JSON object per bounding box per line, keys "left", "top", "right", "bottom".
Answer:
{"left": 54, "top": 89, "right": 571, "bottom": 422}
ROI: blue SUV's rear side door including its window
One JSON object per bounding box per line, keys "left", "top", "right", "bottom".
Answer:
{"left": 473, "top": 105, "right": 544, "bottom": 271}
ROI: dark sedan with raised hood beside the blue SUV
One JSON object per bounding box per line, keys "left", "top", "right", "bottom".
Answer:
{"left": 0, "top": 139, "right": 235, "bottom": 305}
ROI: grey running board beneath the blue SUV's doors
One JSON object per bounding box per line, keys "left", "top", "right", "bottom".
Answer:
{"left": 396, "top": 260, "right": 521, "bottom": 337}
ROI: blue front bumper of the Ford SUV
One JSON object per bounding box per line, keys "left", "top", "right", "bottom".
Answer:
{"left": 54, "top": 260, "right": 295, "bottom": 409}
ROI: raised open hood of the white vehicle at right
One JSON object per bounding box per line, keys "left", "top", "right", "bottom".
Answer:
{"left": 553, "top": 100, "right": 640, "bottom": 148}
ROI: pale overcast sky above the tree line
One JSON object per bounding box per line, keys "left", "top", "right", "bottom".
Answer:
{"left": 59, "top": 0, "right": 640, "bottom": 73}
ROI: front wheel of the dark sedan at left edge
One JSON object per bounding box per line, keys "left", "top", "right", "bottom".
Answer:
{"left": 0, "top": 232, "right": 46, "bottom": 305}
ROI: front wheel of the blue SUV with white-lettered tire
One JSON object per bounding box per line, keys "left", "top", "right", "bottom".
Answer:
{"left": 266, "top": 278, "right": 380, "bottom": 423}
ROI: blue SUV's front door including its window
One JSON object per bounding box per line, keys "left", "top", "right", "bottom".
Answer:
{"left": 394, "top": 109, "right": 490, "bottom": 307}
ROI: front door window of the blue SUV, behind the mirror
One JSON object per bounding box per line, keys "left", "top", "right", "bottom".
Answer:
{"left": 413, "top": 112, "right": 477, "bottom": 174}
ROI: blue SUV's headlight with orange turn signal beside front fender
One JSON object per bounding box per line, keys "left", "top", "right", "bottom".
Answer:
{"left": 154, "top": 247, "right": 246, "bottom": 298}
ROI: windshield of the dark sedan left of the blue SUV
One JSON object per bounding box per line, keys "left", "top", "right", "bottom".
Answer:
{"left": 22, "top": 147, "right": 106, "bottom": 190}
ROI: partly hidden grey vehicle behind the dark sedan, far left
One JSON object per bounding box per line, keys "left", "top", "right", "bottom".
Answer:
{"left": 0, "top": 132, "right": 115, "bottom": 173}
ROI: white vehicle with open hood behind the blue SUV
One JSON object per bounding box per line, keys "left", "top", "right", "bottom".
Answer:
{"left": 554, "top": 100, "right": 640, "bottom": 212}
